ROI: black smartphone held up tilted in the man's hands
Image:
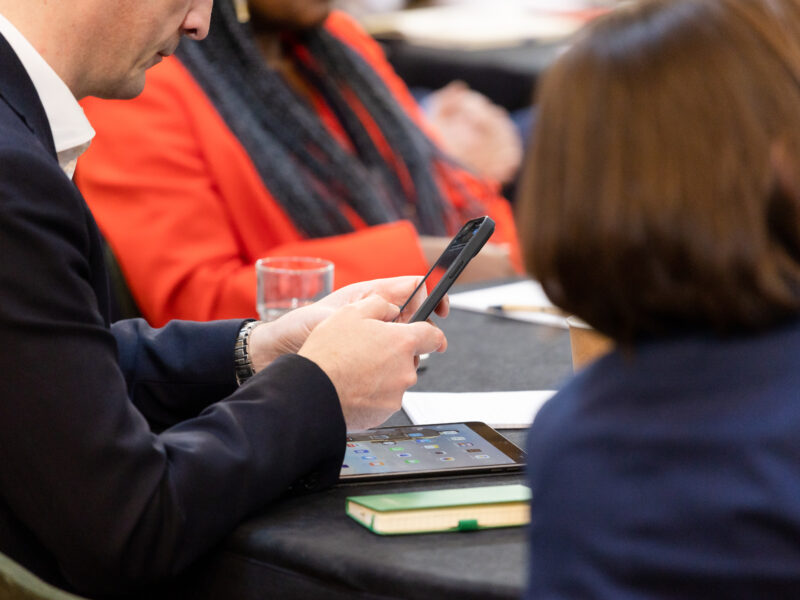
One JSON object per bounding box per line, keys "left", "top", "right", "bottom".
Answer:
{"left": 398, "top": 217, "right": 494, "bottom": 323}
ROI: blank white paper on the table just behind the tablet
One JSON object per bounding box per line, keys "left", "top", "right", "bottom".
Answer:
{"left": 403, "top": 390, "right": 555, "bottom": 429}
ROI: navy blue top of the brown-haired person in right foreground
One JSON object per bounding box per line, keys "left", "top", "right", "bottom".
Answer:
{"left": 526, "top": 322, "right": 800, "bottom": 600}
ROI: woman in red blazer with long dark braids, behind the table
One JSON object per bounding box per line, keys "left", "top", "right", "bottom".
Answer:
{"left": 76, "top": 0, "right": 520, "bottom": 324}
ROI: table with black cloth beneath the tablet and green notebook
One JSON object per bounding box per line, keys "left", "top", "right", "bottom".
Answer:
{"left": 181, "top": 288, "right": 572, "bottom": 600}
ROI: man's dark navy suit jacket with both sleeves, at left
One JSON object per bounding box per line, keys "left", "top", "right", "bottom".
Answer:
{"left": 0, "top": 37, "right": 344, "bottom": 595}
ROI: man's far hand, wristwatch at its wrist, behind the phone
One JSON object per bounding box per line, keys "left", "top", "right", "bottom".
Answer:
{"left": 250, "top": 276, "right": 450, "bottom": 372}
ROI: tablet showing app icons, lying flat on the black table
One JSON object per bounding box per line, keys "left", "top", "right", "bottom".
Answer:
{"left": 339, "top": 421, "right": 525, "bottom": 482}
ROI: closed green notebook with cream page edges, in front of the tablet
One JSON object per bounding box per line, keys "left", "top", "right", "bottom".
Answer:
{"left": 345, "top": 485, "right": 531, "bottom": 535}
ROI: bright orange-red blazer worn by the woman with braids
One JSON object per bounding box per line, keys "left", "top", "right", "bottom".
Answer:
{"left": 76, "top": 13, "right": 521, "bottom": 325}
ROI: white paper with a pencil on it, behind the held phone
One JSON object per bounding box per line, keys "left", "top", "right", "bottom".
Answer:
{"left": 450, "top": 281, "right": 567, "bottom": 329}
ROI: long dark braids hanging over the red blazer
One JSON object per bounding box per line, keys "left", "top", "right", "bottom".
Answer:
{"left": 178, "top": 0, "right": 481, "bottom": 237}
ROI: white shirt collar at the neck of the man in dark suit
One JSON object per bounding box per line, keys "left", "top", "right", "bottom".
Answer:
{"left": 0, "top": 14, "right": 94, "bottom": 178}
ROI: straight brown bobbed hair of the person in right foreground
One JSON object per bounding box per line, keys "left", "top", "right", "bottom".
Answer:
{"left": 517, "top": 0, "right": 800, "bottom": 343}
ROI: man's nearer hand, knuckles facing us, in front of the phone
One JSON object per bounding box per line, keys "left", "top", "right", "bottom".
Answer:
{"left": 298, "top": 287, "right": 447, "bottom": 431}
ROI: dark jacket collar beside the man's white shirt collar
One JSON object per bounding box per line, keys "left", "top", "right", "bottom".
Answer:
{"left": 0, "top": 35, "right": 56, "bottom": 158}
